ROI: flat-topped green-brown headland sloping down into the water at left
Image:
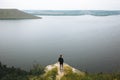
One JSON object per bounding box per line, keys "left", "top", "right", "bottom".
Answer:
{"left": 0, "top": 9, "right": 40, "bottom": 19}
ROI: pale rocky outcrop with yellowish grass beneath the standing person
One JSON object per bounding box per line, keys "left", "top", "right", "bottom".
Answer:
{"left": 45, "top": 63, "right": 85, "bottom": 80}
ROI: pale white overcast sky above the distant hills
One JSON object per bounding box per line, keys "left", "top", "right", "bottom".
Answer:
{"left": 0, "top": 0, "right": 120, "bottom": 10}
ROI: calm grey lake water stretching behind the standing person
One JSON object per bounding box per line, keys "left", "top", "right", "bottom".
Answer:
{"left": 0, "top": 16, "right": 120, "bottom": 72}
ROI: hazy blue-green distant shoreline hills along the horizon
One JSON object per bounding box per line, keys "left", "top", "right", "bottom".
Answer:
{"left": 24, "top": 10, "right": 120, "bottom": 16}
